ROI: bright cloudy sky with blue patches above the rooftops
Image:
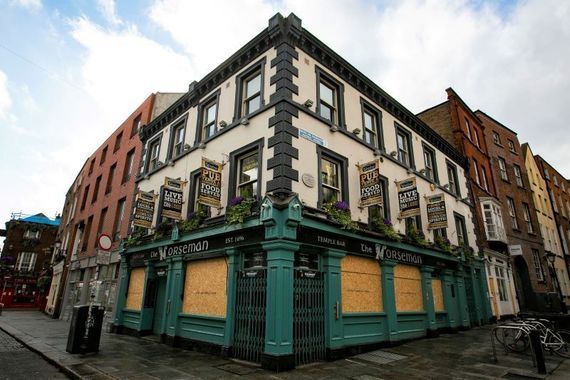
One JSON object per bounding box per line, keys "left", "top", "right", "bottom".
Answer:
{"left": 0, "top": 0, "right": 570, "bottom": 245}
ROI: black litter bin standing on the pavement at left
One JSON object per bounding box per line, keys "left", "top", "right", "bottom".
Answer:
{"left": 66, "top": 305, "right": 105, "bottom": 354}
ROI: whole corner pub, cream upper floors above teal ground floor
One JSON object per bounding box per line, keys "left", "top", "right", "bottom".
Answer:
{"left": 114, "top": 14, "right": 491, "bottom": 370}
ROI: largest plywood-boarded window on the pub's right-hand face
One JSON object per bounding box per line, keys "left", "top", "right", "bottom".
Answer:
{"left": 340, "top": 256, "right": 383, "bottom": 313}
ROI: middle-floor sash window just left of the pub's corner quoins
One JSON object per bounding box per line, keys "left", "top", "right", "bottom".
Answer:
{"left": 228, "top": 139, "right": 263, "bottom": 201}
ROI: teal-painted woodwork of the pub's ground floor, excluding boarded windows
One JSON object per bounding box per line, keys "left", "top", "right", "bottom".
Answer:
{"left": 115, "top": 196, "right": 491, "bottom": 368}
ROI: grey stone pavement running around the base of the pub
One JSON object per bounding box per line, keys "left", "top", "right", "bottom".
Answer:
{"left": 0, "top": 310, "right": 570, "bottom": 380}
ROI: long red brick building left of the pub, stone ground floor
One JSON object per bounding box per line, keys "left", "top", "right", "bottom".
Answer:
{"left": 54, "top": 93, "right": 179, "bottom": 326}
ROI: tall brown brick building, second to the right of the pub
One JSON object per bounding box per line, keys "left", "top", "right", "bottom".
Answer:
{"left": 475, "top": 111, "right": 554, "bottom": 311}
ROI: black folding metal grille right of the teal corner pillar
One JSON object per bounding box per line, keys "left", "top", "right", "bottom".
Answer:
{"left": 293, "top": 269, "right": 325, "bottom": 365}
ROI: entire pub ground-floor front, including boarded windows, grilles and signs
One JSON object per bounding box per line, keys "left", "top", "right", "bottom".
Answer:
{"left": 114, "top": 196, "right": 491, "bottom": 370}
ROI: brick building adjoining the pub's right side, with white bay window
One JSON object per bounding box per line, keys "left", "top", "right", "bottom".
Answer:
{"left": 418, "top": 88, "right": 519, "bottom": 318}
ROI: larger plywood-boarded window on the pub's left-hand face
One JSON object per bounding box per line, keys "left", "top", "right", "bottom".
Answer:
{"left": 182, "top": 257, "right": 228, "bottom": 317}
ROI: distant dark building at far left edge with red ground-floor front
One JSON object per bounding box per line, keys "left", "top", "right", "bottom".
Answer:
{"left": 0, "top": 214, "right": 59, "bottom": 308}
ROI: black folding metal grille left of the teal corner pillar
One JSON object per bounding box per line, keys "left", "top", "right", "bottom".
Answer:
{"left": 233, "top": 269, "right": 267, "bottom": 363}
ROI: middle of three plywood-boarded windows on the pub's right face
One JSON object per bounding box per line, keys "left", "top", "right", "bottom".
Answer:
{"left": 394, "top": 264, "right": 424, "bottom": 311}
